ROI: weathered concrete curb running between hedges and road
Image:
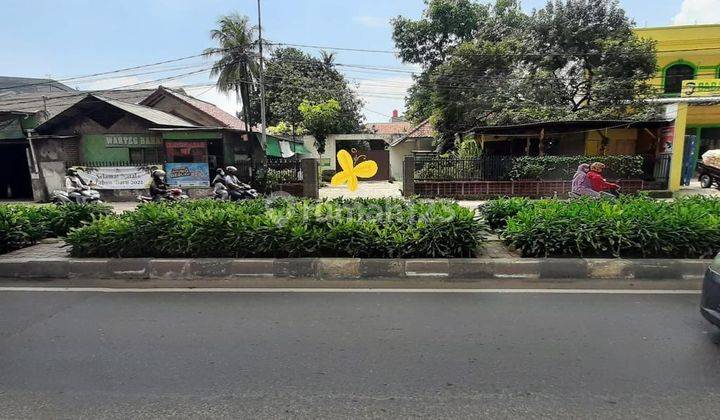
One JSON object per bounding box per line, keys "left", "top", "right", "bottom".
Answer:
{"left": 0, "top": 258, "right": 712, "bottom": 282}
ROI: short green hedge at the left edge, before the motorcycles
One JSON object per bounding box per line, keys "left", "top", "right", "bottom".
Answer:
{"left": 0, "top": 204, "right": 112, "bottom": 254}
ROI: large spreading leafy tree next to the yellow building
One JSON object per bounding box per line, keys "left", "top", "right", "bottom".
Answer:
{"left": 398, "top": 0, "right": 656, "bottom": 148}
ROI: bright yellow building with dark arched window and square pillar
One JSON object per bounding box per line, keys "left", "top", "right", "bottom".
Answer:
{"left": 635, "top": 25, "right": 720, "bottom": 190}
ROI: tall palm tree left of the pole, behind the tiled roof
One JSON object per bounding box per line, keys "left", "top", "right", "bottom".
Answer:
{"left": 204, "top": 13, "right": 260, "bottom": 130}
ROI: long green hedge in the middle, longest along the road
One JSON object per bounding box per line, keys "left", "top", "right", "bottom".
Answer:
{"left": 67, "top": 199, "right": 486, "bottom": 258}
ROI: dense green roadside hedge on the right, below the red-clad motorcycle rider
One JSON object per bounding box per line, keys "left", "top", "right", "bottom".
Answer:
{"left": 498, "top": 197, "right": 720, "bottom": 258}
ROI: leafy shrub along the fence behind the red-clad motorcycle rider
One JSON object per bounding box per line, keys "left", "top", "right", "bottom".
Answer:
{"left": 510, "top": 156, "right": 644, "bottom": 179}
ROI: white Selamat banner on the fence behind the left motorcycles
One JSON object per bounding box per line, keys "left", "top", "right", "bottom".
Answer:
{"left": 78, "top": 165, "right": 162, "bottom": 190}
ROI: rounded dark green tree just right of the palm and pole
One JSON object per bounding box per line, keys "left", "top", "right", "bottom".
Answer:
{"left": 253, "top": 48, "right": 362, "bottom": 138}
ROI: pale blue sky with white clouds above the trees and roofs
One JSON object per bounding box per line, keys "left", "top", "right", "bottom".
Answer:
{"left": 0, "top": 0, "right": 720, "bottom": 121}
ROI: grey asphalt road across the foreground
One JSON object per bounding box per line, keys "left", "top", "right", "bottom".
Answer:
{"left": 0, "top": 291, "right": 720, "bottom": 419}
